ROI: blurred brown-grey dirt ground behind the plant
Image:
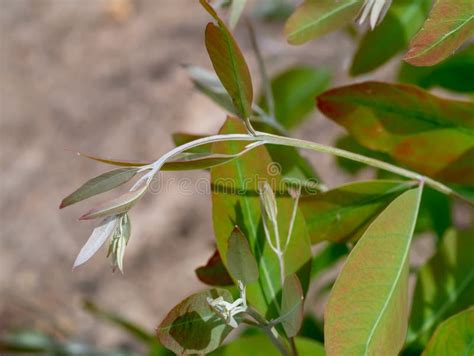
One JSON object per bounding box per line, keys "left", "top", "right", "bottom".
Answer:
{"left": 0, "top": 0, "right": 434, "bottom": 347}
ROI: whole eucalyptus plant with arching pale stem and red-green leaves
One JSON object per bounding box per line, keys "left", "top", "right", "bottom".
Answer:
{"left": 61, "top": 0, "right": 474, "bottom": 355}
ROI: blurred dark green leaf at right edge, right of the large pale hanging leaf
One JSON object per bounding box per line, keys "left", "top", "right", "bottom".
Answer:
{"left": 407, "top": 229, "right": 474, "bottom": 352}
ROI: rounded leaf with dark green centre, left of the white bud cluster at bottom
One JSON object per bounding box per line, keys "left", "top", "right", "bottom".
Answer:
{"left": 156, "top": 289, "right": 232, "bottom": 355}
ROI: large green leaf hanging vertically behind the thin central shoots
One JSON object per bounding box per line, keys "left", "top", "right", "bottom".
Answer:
{"left": 211, "top": 118, "right": 311, "bottom": 318}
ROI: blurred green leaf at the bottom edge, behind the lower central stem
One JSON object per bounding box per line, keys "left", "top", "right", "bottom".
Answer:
{"left": 211, "top": 334, "right": 325, "bottom": 356}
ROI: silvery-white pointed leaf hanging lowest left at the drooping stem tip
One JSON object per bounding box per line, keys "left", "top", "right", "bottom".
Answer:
{"left": 73, "top": 215, "right": 119, "bottom": 268}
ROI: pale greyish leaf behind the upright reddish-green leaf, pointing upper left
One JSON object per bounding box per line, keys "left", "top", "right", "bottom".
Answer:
{"left": 185, "top": 66, "right": 237, "bottom": 115}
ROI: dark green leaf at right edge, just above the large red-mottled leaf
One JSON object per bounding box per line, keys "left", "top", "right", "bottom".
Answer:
{"left": 398, "top": 45, "right": 474, "bottom": 93}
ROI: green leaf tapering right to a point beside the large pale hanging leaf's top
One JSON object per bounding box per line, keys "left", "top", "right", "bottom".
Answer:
{"left": 300, "top": 180, "right": 414, "bottom": 244}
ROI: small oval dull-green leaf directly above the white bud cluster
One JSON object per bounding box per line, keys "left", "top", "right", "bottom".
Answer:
{"left": 227, "top": 226, "right": 258, "bottom": 284}
